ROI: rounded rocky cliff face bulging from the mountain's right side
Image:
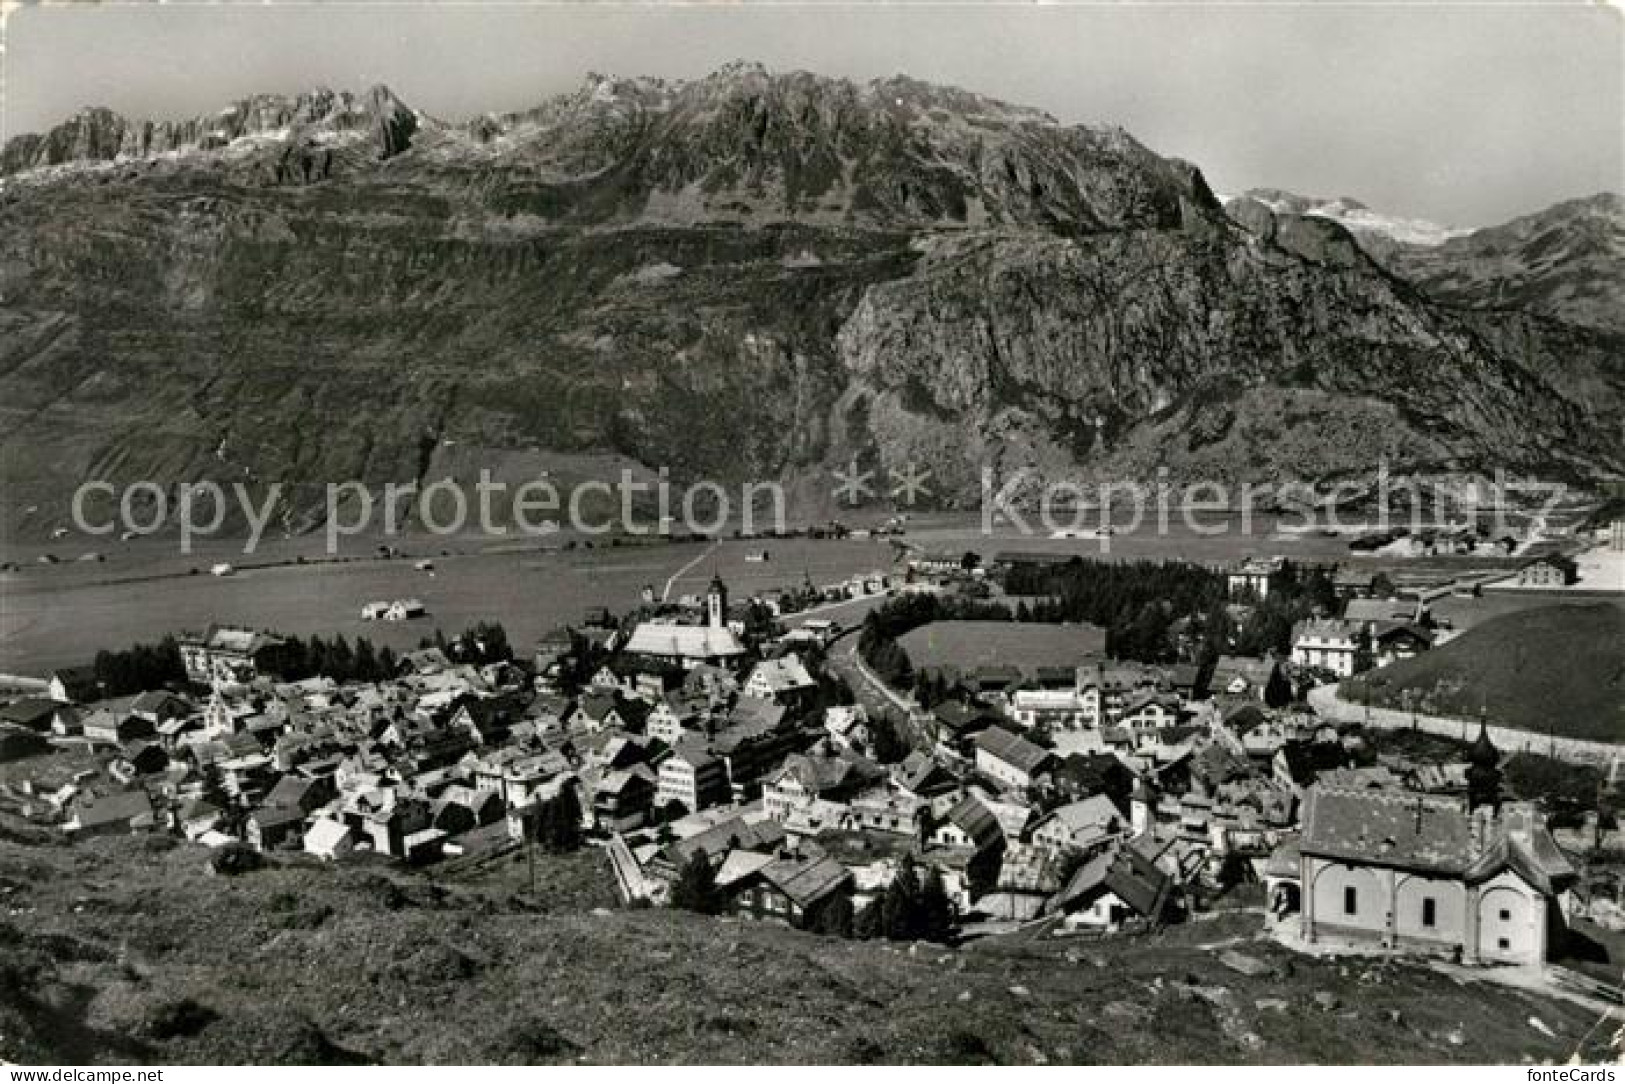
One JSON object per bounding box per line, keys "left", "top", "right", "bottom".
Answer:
{"left": 840, "top": 229, "right": 1617, "bottom": 500}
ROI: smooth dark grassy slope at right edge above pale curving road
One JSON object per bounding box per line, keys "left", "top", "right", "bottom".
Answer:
{"left": 1342, "top": 603, "right": 1625, "bottom": 743}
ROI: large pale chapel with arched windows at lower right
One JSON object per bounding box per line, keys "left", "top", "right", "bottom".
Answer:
{"left": 1269, "top": 787, "right": 1576, "bottom": 964}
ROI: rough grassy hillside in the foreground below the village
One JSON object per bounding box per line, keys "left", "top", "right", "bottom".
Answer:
{"left": 0, "top": 814, "right": 1612, "bottom": 1064}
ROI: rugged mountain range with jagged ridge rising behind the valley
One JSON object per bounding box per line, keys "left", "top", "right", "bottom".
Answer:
{"left": 0, "top": 63, "right": 1625, "bottom": 533}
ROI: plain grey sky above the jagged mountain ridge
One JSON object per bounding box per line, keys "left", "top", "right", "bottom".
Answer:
{"left": 0, "top": 0, "right": 1625, "bottom": 226}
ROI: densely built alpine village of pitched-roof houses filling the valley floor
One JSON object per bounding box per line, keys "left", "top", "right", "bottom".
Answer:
{"left": 0, "top": 548, "right": 1619, "bottom": 994}
